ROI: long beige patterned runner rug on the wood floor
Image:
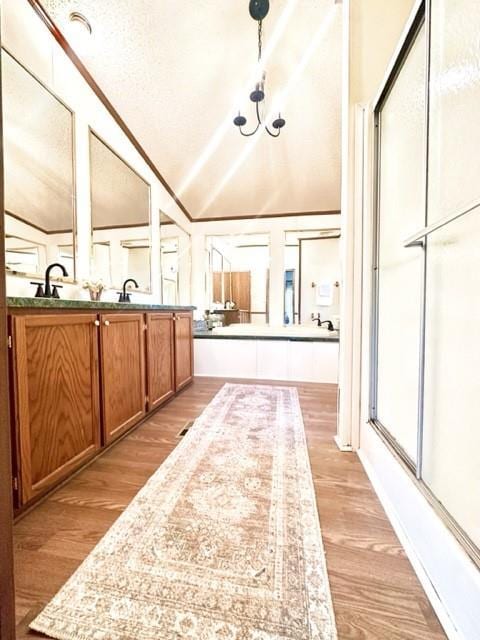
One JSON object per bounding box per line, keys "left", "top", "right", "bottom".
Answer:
{"left": 30, "top": 384, "right": 337, "bottom": 640}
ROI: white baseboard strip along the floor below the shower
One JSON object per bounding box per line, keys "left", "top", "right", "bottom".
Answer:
{"left": 357, "top": 449, "right": 466, "bottom": 640}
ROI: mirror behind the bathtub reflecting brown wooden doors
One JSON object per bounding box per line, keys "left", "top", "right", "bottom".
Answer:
{"left": 206, "top": 233, "right": 270, "bottom": 326}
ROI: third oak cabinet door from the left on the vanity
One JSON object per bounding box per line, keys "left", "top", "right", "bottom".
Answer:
{"left": 147, "top": 313, "right": 175, "bottom": 410}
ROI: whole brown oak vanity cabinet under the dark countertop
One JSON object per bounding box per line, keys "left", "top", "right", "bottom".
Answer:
{"left": 9, "top": 309, "right": 193, "bottom": 509}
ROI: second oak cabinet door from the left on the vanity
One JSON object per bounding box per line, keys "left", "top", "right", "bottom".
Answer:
{"left": 100, "top": 313, "right": 146, "bottom": 444}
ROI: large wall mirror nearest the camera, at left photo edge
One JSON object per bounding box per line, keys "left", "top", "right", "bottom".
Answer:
{"left": 2, "top": 49, "right": 75, "bottom": 281}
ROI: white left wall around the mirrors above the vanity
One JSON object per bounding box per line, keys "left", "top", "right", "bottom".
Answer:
{"left": 2, "top": 0, "right": 191, "bottom": 303}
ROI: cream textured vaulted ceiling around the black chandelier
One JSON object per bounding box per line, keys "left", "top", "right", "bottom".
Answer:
{"left": 43, "top": 0, "right": 341, "bottom": 218}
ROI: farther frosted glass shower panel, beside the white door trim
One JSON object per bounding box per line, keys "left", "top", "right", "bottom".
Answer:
{"left": 372, "top": 21, "right": 426, "bottom": 465}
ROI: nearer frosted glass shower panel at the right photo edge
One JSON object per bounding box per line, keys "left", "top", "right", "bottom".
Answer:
{"left": 422, "top": 0, "right": 480, "bottom": 557}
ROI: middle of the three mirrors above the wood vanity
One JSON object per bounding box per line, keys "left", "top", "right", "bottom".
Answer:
{"left": 90, "top": 131, "right": 151, "bottom": 293}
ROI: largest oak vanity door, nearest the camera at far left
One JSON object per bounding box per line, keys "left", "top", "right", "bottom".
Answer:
{"left": 12, "top": 314, "right": 100, "bottom": 504}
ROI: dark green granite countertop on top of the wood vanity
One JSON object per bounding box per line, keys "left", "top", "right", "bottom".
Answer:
{"left": 7, "top": 297, "right": 196, "bottom": 311}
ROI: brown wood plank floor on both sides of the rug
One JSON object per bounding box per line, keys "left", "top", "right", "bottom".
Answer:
{"left": 15, "top": 378, "right": 446, "bottom": 640}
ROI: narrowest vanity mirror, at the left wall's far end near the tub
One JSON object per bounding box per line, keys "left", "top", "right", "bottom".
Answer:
{"left": 160, "top": 211, "right": 191, "bottom": 305}
